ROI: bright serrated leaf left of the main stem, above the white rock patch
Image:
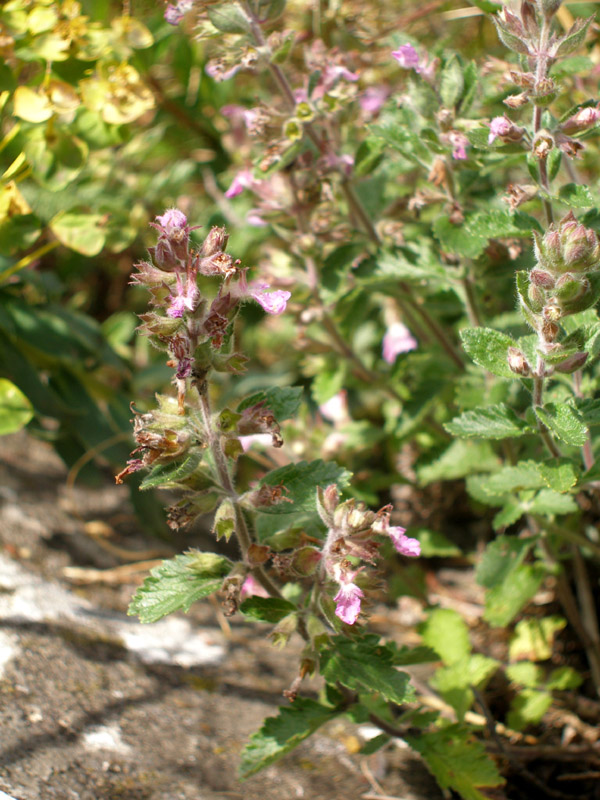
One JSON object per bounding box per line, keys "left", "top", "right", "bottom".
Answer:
{"left": 127, "top": 551, "right": 231, "bottom": 622}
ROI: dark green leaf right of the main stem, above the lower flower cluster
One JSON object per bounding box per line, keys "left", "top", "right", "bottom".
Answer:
{"left": 260, "top": 459, "right": 350, "bottom": 514}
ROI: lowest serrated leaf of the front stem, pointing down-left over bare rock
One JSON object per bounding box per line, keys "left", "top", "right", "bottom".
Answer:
{"left": 240, "top": 697, "right": 341, "bottom": 780}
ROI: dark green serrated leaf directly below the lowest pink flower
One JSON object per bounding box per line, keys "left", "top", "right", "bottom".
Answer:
{"left": 321, "top": 636, "right": 414, "bottom": 705}
